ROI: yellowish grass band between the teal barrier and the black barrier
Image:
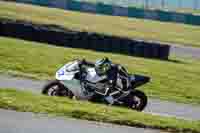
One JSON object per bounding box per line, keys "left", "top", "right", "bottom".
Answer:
{"left": 0, "top": 1, "right": 200, "bottom": 47}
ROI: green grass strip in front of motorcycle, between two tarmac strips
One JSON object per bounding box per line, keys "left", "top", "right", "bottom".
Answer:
{"left": 0, "top": 89, "right": 200, "bottom": 133}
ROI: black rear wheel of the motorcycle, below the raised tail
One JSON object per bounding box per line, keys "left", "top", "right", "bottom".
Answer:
{"left": 128, "top": 90, "right": 148, "bottom": 111}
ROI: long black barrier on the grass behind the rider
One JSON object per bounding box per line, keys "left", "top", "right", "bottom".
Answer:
{"left": 0, "top": 20, "right": 169, "bottom": 59}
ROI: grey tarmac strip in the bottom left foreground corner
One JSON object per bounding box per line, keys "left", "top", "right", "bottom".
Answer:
{"left": 0, "top": 109, "right": 160, "bottom": 133}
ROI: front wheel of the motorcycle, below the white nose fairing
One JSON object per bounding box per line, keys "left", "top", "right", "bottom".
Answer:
{"left": 42, "top": 80, "right": 73, "bottom": 98}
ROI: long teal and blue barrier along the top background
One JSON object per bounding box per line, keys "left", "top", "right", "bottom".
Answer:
{"left": 10, "top": 0, "right": 200, "bottom": 25}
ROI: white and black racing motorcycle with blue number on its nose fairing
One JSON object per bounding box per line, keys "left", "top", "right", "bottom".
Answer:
{"left": 42, "top": 60, "right": 150, "bottom": 111}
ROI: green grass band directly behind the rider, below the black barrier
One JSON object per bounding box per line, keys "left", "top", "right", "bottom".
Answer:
{"left": 0, "top": 37, "right": 200, "bottom": 104}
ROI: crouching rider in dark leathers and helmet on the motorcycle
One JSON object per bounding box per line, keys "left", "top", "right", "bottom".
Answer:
{"left": 81, "top": 58, "right": 128, "bottom": 103}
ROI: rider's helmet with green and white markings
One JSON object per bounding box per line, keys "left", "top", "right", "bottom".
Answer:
{"left": 95, "top": 58, "right": 112, "bottom": 75}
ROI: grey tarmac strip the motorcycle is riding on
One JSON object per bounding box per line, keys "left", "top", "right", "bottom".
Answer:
{"left": 0, "top": 75, "right": 200, "bottom": 120}
